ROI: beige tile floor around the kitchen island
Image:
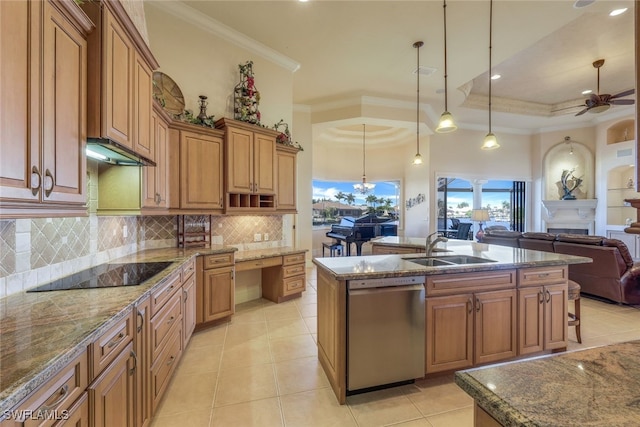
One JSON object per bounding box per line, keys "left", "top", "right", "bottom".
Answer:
{"left": 152, "top": 269, "right": 640, "bottom": 427}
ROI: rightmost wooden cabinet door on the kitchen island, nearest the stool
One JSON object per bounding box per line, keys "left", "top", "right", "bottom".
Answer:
{"left": 544, "top": 283, "right": 569, "bottom": 350}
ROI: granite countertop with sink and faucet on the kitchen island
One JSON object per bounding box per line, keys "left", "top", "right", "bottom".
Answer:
{"left": 313, "top": 237, "right": 592, "bottom": 280}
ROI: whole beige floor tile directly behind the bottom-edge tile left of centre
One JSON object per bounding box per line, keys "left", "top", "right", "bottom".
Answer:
{"left": 214, "top": 364, "right": 278, "bottom": 407}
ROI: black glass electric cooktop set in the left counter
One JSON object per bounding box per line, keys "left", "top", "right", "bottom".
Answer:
{"left": 27, "top": 262, "right": 171, "bottom": 292}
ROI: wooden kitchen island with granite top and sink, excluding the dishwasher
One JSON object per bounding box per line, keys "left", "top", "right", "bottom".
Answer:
{"left": 313, "top": 241, "right": 591, "bottom": 403}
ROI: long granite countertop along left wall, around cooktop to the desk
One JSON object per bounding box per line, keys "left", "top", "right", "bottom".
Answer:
{"left": 0, "top": 245, "right": 306, "bottom": 417}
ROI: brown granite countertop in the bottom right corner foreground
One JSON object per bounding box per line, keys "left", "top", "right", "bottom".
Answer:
{"left": 455, "top": 341, "right": 640, "bottom": 427}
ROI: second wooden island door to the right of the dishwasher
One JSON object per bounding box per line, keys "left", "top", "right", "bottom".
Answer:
{"left": 474, "top": 289, "right": 517, "bottom": 364}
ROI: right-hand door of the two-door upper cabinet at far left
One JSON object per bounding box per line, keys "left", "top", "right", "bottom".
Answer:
{"left": 41, "top": 2, "right": 87, "bottom": 204}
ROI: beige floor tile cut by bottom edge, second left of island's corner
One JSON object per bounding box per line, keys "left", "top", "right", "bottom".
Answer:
{"left": 210, "top": 397, "right": 284, "bottom": 427}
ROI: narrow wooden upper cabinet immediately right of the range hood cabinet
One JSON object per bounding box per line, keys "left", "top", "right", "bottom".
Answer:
{"left": 142, "top": 102, "right": 171, "bottom": 213}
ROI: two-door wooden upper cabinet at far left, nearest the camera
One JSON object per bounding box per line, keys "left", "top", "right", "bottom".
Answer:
{"left": 0, "top": 1, "right": 92, "bottom": 218}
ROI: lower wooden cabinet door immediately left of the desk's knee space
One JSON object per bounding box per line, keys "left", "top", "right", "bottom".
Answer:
{"left": 203, "top": 267, "right": 235, "bottom": 322}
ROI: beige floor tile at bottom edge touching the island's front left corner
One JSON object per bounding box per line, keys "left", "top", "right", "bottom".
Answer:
{"left": 280, "top": 388, "right": 357, "bottom": 427}
